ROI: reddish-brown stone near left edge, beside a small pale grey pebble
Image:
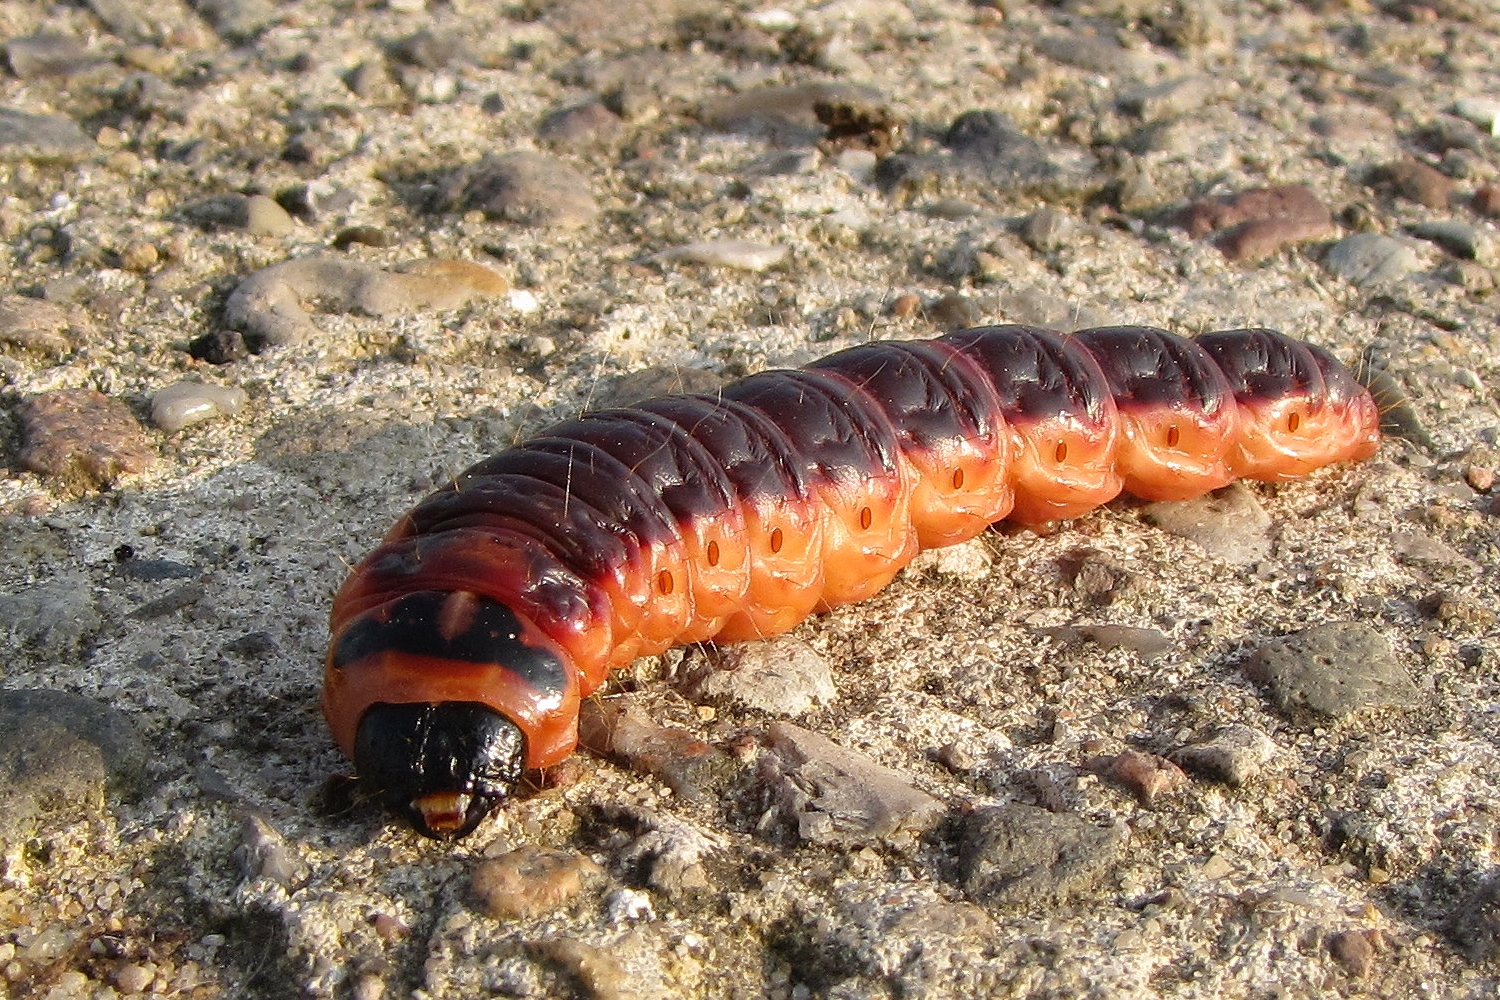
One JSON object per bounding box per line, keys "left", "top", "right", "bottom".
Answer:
{"left": 17, "top": 388, "right": 153, "bottom": 489}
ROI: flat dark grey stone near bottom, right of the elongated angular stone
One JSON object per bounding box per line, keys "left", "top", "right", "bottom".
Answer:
{"left": 959, "top": 802, "right": 1125, "bottom": 912}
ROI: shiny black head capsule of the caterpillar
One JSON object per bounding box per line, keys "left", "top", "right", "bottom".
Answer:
{"left": 354, "top": 702, "right": 527, "bottom": 840}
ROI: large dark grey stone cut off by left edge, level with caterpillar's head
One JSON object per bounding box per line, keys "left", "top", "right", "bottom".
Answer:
{"left": 0, "top": 690, "right": 147, "bottom": 846}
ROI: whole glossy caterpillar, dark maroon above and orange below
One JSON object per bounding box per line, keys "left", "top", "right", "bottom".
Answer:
{"left": 323, "top": 325, "right": 1380, "bottom": 838}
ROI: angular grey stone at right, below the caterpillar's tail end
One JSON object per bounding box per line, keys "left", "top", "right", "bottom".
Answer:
{"left": 1245, "top": 622, "right": 1418, "bottom": 718}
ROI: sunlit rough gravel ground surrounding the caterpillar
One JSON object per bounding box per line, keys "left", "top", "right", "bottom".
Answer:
{"left": 0, "top": 0, "right": 1500, "bottom": 1000}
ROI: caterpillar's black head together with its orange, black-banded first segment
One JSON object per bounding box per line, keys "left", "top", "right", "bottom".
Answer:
{"left": 323, "top": 587, "right": 579, "bottom": 840}
